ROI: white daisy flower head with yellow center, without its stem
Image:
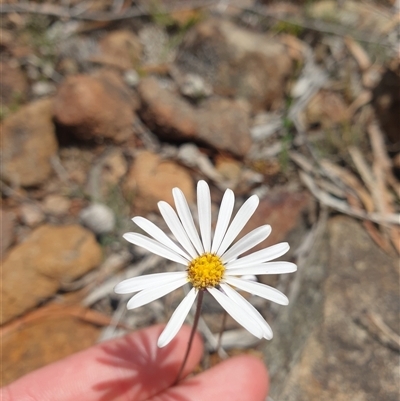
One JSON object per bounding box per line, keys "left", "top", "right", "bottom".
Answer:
{"left": 115, "top": 181, "right": 297, "bottom": 347}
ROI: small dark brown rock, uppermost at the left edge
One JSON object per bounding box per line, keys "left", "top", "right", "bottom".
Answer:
{"left": 0, "top": 61, "right": 28, "bottom": 107}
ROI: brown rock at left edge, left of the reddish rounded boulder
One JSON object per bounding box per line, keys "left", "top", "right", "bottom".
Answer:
{"left": 0, "top": 99, "right": 58, "bottom": 186}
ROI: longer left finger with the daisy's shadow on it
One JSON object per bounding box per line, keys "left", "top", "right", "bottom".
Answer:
{"left": 2, "top": 325, "right": 203, "bottom": 401}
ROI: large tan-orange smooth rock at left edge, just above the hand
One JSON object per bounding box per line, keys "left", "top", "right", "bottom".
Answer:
{"left": 1, "top": 225, "right": 101, "bottom": 323}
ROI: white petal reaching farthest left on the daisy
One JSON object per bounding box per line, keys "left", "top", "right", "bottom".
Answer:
{"left": 114, "top": 272, "right": 187, "bottom": 294}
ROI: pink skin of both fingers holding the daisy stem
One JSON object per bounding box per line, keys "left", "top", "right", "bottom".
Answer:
{"left": 0, "top": 325, "right": 268, "bottom": 401}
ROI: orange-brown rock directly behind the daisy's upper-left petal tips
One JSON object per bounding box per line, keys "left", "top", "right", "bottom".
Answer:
{"left": 123, "top": 152, "right": 194, "bottom": 213}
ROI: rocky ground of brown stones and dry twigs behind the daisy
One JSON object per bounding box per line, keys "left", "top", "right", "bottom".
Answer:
{"left": 0, "top": 0, "right": 400, "bottom": 401}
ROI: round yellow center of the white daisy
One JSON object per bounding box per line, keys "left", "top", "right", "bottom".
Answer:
{"left": 187, "top": 253, "right": 225, "bottom": 290}
